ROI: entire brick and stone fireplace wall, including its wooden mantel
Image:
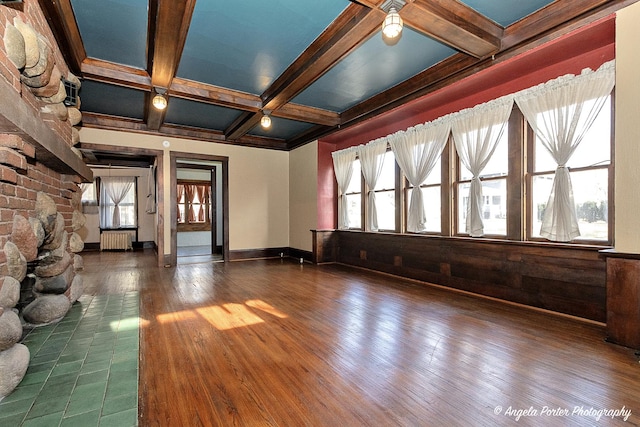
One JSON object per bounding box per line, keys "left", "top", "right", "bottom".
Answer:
{"left": 0, "top": 0, "right": 90, "bottom": 400}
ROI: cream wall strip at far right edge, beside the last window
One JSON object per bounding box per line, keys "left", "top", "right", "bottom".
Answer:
{"left": 614, "top": 3, "right": 640, "bottom": 253}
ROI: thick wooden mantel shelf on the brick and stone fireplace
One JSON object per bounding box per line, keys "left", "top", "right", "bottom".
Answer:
{"left": 0, "top": 79, "right": 93, "bottom": 182}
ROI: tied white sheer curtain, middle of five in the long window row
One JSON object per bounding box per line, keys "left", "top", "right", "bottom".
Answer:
{"left": 389, "top": 119, "right": 451, "bottom": 233}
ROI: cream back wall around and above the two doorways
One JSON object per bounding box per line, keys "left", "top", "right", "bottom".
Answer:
{"left": 80, "top": 128, "right": 289, "bottom": 255}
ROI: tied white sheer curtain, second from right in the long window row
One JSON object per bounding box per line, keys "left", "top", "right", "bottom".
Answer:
{"left": 451, "top": 97, "right": 513, "bottom": 237}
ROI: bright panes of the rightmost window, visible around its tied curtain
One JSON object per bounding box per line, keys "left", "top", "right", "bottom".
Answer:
{"left": 530, "top": 97, "right": 613, "bottom": 241}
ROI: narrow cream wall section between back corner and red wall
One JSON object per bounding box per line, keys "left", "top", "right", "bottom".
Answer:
{"left": 289, "top": 141, "right": 318, "bottom": 251}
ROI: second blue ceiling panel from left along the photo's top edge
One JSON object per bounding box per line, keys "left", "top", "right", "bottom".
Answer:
{"left": 177, "top": 0, "right": 349, "bottom": 95}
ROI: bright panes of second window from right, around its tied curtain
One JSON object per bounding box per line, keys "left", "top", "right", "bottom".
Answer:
{"left": 456, "top": 126, "right": 509, "bottom": 236}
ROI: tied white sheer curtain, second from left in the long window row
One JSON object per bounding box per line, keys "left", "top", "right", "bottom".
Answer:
{"left": 358, "top": 138, "right": 387, "bottom": 231}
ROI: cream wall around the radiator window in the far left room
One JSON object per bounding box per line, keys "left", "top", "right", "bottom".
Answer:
{"left": 80, "top": 167, "right": 157, "bottom": 243}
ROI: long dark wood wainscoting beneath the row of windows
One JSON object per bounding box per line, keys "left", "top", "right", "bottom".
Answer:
{"left": 313, "top": 230, "right": 607, "bottom": 323}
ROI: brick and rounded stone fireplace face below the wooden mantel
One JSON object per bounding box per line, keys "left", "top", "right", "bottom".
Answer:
{"left": 0, "top": 134, "right": 84, "bottom": 400}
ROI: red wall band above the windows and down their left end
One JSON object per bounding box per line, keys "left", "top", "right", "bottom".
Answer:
{"left": 318, "top": 15, "right": 615, "bottom": 229}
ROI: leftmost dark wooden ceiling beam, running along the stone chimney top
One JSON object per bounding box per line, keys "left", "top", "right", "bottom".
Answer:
{"left": 38, "top": 0, "right": 87, "bottom": 75}
